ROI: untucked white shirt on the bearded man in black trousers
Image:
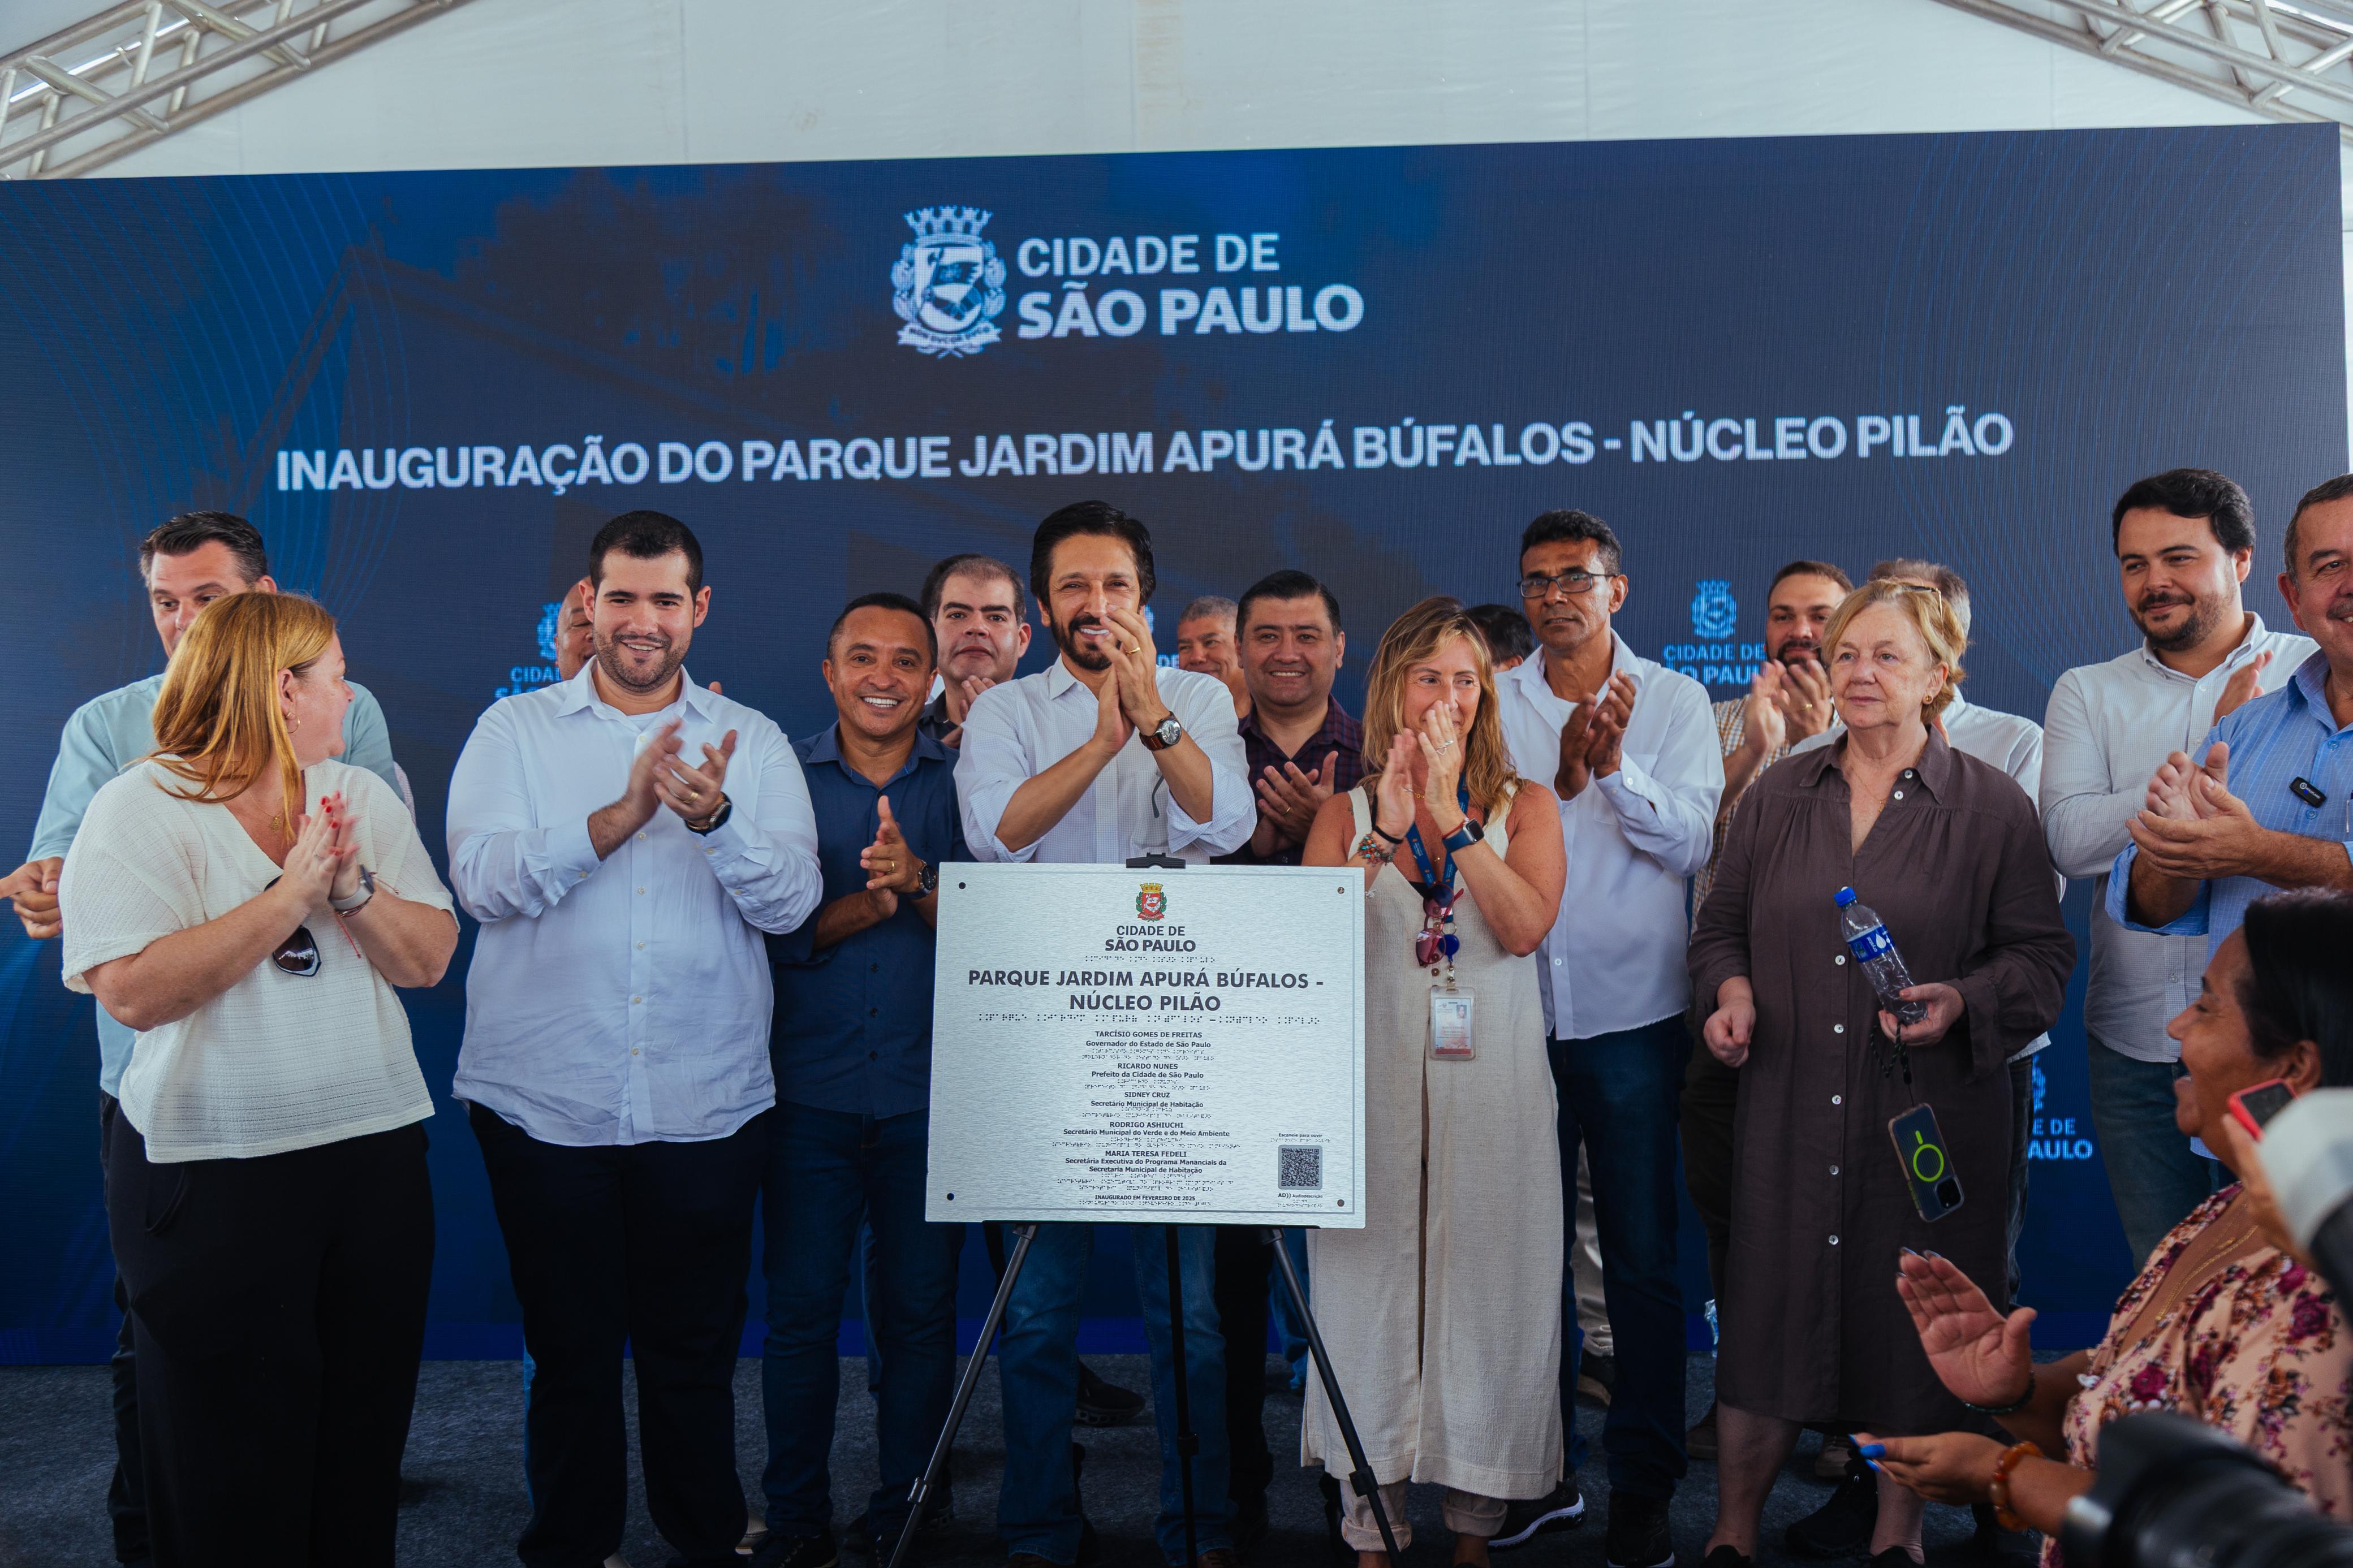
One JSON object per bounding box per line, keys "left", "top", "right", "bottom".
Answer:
{"left": 450, "top": 666, "right": 821, "bottom": 1147}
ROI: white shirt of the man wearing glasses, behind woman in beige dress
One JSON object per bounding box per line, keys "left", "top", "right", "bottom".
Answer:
{"left": 1494, "top": 632, "right": 1725, "bottom": 1039}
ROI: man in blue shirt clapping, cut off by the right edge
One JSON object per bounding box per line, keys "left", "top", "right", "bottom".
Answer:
{"left": 2108, "top": 475, "right": 2353, "bottom": 952}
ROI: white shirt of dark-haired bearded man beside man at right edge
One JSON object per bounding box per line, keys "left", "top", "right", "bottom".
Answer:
{"left": 2042, "top": 616, "right": 2318, "bottom": 1062}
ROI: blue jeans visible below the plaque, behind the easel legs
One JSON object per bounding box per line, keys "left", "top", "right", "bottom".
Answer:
{"left": 993, "top": 1225, "right": 1233, "bottom": 1563}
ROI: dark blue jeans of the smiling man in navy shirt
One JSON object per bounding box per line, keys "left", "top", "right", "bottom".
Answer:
{"left": 760, "top": 1100, "right": 965, "bottom": 1535}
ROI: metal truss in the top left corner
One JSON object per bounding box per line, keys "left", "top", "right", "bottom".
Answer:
{"left": 0, "top": 0, "right": 466, "bottom": 179}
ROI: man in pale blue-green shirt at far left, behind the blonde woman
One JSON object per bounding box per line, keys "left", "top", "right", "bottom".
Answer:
{"left": 0, "top": 512, "right": 400, "bottom": 1563}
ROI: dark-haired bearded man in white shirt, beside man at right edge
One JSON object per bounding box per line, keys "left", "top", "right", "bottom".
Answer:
{"left": 2042, "top": 468, "right": 2313, "bottom": 1265}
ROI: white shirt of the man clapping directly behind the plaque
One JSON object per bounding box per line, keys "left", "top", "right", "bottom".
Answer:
{"left": 955, "top": 658, "right": 1259, "bottom": 865}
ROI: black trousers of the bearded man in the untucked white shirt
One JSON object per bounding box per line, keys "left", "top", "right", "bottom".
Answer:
{"left": 468, "top": 1105, "right": 772, "bottom": 1568}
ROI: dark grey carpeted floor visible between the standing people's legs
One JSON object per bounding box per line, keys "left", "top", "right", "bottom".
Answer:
{"left": 0, "top": 1357, "right": 2031, "bottom": 1568}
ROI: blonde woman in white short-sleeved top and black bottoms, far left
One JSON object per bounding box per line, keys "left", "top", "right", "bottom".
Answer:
{"left": 59, "top": 593, "right": 456, "bottom": 1568}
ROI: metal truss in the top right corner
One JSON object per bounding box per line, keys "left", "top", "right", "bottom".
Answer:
{"left": 1941, "top": 0, "right": 2353, "bottom": 141}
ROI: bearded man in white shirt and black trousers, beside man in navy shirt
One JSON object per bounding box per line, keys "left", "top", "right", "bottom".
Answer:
{"left": 450, "top": 512, "right": 821, "bottom": 1568}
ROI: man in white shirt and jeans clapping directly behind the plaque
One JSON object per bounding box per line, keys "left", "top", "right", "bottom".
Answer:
{"left": 955, "top": 501, "right": 1261, "bottom": 1568}
